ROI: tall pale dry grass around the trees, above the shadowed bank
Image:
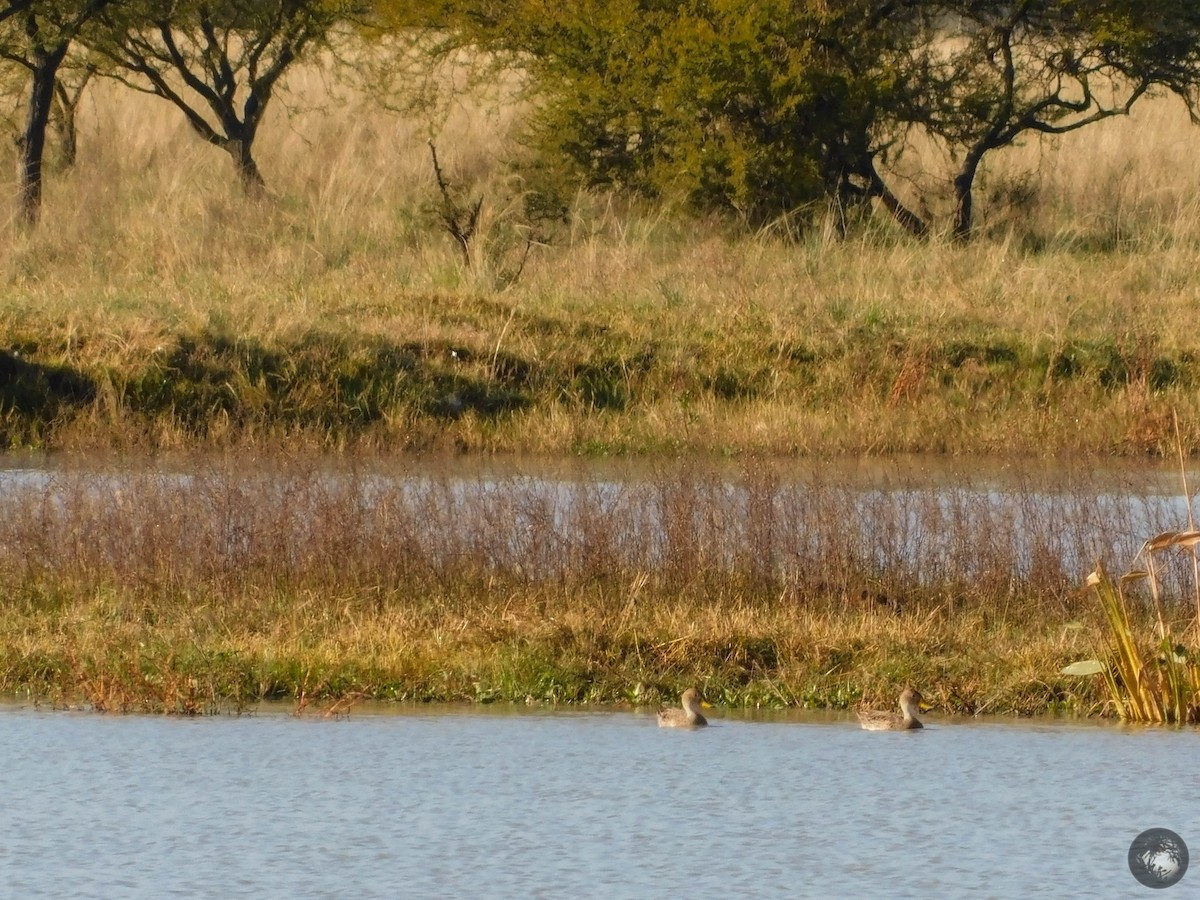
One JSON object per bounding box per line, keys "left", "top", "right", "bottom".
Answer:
{"left": 0, "top": 63, "right": 1200, "bottom": 340}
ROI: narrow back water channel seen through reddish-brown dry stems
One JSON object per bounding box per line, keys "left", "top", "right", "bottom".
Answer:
{"left": 0, "top": 456, "right": 1195, "bottom": 596}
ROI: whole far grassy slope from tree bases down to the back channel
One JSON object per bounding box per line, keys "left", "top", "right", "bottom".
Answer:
{"left": 0, "top": 79, "right": 1200, "bottom": 455}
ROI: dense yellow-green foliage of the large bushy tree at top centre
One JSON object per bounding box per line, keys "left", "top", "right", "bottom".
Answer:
{"left": 468, "top": 0, "right": 881, "bottom": 222}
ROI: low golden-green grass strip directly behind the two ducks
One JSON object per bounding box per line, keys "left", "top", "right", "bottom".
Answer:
{"left": 0, "top": 582, "right": 1104, "bottom": 714}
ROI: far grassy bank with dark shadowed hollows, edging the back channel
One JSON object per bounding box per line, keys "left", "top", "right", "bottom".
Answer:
{"left": 9, "top": 296, "right": 1200, "bottom": 455}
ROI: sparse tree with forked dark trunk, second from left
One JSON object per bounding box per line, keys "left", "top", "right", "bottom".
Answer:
{"left": 94, "top": 0, "right": 352, "bottom": 194}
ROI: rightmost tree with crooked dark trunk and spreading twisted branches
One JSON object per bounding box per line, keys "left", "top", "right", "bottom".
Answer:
{"left": 881, "top": 0, "right": 1200, "bottom": 239}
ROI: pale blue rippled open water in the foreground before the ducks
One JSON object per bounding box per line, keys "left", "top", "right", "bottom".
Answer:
{"left": 0, "top": 707, "right": 1200, "bottom": 898}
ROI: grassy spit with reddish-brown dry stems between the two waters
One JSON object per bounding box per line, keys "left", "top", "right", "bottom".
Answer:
{"left": 0, "top": 457, "right": 1190, "bottom": 713}
